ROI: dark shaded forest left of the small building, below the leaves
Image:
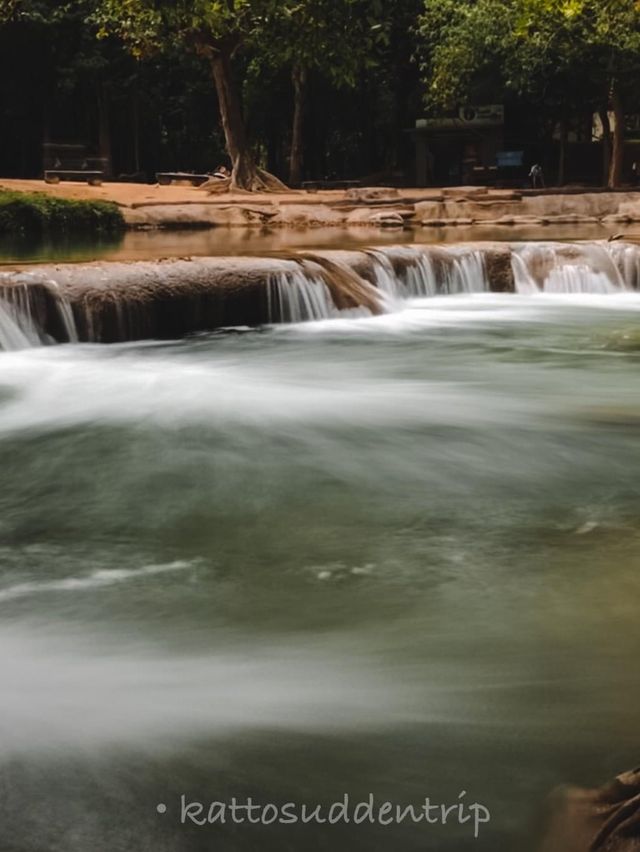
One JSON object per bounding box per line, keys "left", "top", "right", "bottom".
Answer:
{"left": 0, "top": 2, "right": 421, "bottom": 180}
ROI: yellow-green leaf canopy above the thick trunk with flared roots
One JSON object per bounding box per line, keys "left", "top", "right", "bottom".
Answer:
{"left": 91, "top": 0, "right": 394, "bottom": 85}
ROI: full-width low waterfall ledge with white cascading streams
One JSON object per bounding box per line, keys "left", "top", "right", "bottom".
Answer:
{"left": 0, "top": 242, "right": 640, "bottom": 349}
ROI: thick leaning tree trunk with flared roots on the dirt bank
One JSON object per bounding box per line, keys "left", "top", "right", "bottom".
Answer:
{"left": 207, "top": 45, "right": 286, "bottom": 192}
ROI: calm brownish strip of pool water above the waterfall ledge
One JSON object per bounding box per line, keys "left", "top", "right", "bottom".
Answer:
{"left": 0, "top": 225, "right": 620, "bottom": 266}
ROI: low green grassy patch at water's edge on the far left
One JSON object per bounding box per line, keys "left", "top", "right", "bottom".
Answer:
{"left": 0, "top": 189, "right": 124, "bottom": 235}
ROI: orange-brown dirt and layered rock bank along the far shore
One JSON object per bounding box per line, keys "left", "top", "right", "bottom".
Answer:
{"left": 0, "top": 179, "right": 640, "bottom": 231}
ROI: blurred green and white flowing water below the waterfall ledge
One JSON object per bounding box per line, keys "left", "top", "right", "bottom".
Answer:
{"left": 0, "top": 270, "right": 640, "bottom": 852}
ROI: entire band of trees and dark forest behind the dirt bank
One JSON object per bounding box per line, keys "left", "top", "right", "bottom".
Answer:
{"left": 0, "top": 0, "right": 640, "bottom": 187}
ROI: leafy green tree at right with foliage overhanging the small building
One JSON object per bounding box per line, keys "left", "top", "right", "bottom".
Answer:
{"left": 418, "top": 0, "right": 640, "bottom": 186}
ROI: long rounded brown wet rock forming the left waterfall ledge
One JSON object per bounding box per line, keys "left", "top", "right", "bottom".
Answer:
{"left": 0, "top": 252, "right": 381, "bottom": 343}
